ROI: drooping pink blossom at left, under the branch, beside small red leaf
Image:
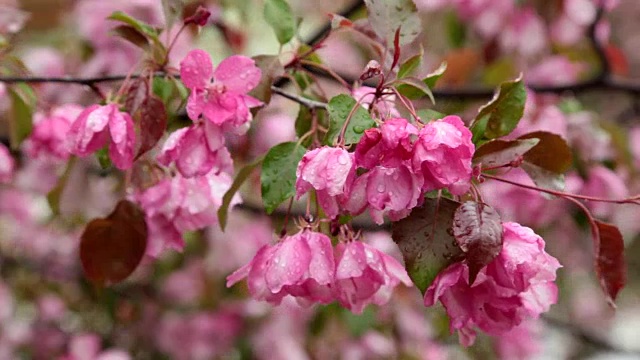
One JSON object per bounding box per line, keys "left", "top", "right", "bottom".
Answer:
{"left": 68, "top": 104, "right": 136, "bottom": 170}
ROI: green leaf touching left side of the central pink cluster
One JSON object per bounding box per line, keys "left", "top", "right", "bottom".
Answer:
{"left": 260, "top": 142, "right": 307, "bottom": 214}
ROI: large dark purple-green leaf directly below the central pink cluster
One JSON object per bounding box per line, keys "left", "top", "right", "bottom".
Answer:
{"left": 392, "top": 198, "right": 463, "bottom": 293}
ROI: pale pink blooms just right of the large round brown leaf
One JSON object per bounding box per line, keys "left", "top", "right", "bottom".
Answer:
{"left": 134, "top": 173, "right": 241, "bottom": 258}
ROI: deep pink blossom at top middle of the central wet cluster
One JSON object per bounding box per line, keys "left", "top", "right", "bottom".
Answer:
{"left": 355, "top": 118, "right": 418, "bottom": 169}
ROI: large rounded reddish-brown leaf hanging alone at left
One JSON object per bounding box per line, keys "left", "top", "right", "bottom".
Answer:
{"left": 80, "top": 200, "right": 147, "bottom": 285}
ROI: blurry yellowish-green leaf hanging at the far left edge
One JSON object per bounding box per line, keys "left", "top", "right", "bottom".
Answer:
{"left": 8, "top": 84, "right": 36, "bottom": 149}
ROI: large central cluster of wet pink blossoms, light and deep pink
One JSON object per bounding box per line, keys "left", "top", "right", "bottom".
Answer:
{"left": 296, "top": 116, "right": 475, "bottom": 224}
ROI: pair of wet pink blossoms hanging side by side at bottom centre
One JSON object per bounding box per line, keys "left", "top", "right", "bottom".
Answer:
{"left": 227, "top": 229, "right": 412, "bottom": 313}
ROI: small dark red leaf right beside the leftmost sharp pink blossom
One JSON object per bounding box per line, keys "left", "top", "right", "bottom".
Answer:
{"left": 138, "top": 95, "right": 167, "bottom": 156}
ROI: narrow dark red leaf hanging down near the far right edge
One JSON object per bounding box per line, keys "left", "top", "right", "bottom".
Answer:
{"left": 594, "top": 220, "right": 627, "bottom": 307}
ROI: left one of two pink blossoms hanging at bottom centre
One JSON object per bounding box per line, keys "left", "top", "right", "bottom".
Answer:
{"left": 227, "top": 230, "right": 336, "bottom": 304}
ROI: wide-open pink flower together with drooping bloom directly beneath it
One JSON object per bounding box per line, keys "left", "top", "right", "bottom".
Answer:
{"left": 158, "top": 50, "right": 262, "bottom": 177}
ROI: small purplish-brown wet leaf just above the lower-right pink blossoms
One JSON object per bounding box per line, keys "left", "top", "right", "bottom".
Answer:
{"left": 453, "top": 201, "right": 502, "bottom": 285}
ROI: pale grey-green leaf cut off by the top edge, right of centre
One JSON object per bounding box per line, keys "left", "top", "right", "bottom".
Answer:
{"left": 364, "top": 0, "right": 422, "bottom": 47}
